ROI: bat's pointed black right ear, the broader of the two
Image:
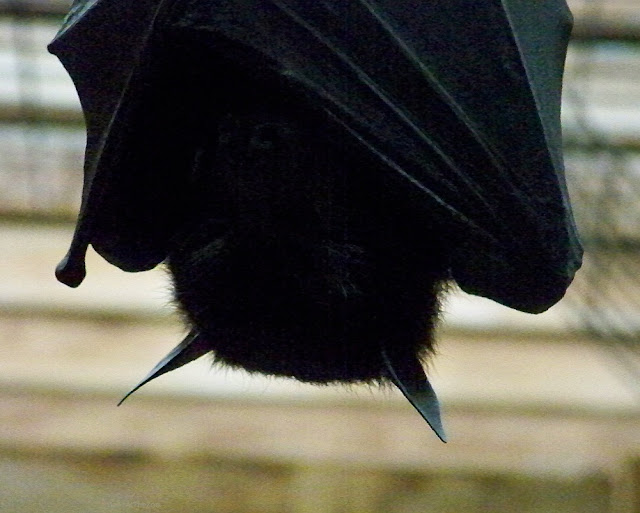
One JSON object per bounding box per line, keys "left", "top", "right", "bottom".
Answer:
{"left": 381, "top": 347, "right": 447, "bottom": 443}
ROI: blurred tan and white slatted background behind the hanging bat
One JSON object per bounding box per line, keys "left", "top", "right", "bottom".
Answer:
{"left": 0, "top": 0, "right": 640, "bottom": 513}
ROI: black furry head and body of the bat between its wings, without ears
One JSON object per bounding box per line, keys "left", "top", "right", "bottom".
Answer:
{"left": 168, "top": 99, "right": 447, "bottom": 383}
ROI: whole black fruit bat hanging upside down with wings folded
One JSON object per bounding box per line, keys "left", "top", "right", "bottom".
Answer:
{"left": 49, "top": 0, "right": 582, "bottom": 440}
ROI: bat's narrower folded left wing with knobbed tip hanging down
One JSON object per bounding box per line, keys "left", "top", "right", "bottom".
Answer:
{"left": 48, "top": 0, "right": 192, "bottom": 286}
